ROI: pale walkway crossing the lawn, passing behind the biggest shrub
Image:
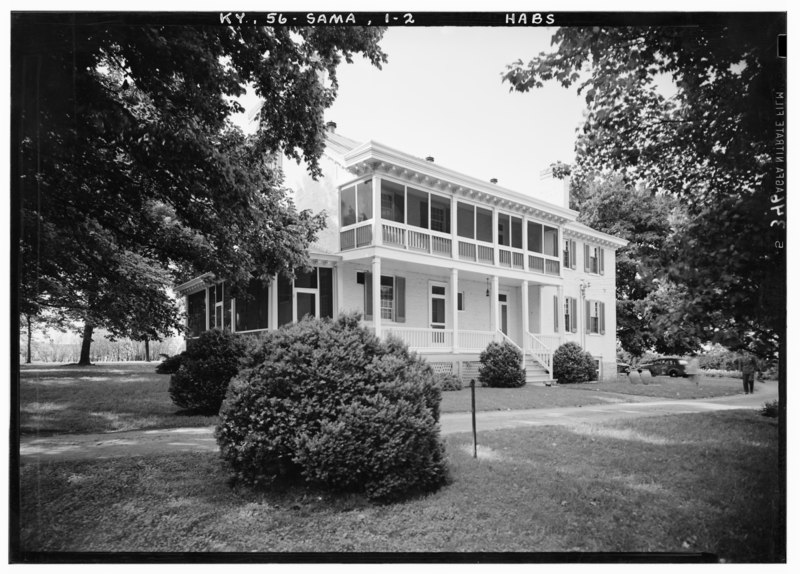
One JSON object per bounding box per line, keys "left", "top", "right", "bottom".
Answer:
{"left": 20, "top": 383, "right": 778, "bottom": 463}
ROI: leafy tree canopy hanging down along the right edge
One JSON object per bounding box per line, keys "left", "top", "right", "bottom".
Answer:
{"left": 504, "top": 22, "right": 786, "bottom": 355}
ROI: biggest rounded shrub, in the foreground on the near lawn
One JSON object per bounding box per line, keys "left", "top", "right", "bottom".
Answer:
{"left": 216, "top": 315, "right": 446, "bottom": 501}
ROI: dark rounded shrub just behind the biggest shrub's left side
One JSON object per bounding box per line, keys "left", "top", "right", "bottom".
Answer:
{"left": 169, "top": 329, "right": 248, "bottom": 414}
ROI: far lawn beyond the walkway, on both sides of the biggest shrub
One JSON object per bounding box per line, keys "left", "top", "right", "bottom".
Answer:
{"left": 20, "top": 362, "right": 761, "bottom": 436}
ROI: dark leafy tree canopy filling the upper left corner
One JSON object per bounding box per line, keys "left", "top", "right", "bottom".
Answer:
{"left": 12, "top": 14, "right": 386, "bottom": 356}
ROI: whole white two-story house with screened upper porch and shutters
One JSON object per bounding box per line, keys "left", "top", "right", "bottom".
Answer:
{"left": 177, "top": 126, "right": 626, "bottom": 388}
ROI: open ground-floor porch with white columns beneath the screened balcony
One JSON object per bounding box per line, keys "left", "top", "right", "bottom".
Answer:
{"left": 336, "top": 251, "right": 562, "bottom": 381}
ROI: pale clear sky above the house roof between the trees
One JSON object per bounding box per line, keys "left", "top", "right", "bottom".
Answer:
{"left": 325, "top": 27, "right": 585, "bottom": 197}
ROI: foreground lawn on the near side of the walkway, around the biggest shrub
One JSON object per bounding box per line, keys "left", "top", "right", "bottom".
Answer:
{"left": 21, "top": 411, "right": 785, "bottom": 562}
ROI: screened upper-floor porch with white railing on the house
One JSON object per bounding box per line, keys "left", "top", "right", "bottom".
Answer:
{"left": 339, "top": 177, "right": 561, "bottom": 277}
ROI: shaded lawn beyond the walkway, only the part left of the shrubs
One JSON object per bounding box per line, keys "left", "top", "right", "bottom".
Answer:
{"left": 19, "top": 362, "right": 217, "bottom": 435}
